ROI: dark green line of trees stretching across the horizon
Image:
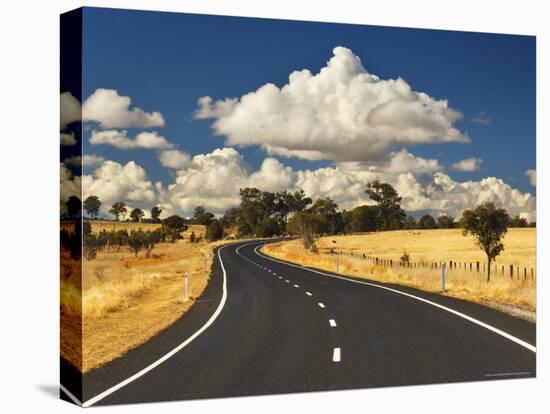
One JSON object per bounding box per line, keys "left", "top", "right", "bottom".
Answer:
{"left": 62, "top": 180, "right": 535, "bottom": 277}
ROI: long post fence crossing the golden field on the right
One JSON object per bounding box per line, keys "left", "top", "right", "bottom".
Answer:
{"left": 329, "top": 250, "right": 536, "bottom": 280}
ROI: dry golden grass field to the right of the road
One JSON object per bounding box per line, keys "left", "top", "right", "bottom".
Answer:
{"left": 262, "top": 229, "right": 536, "bottom": 310}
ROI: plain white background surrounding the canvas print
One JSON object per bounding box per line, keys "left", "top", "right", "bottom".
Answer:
{"left": 0, "top": 0, "right": 550, "bottom": 413}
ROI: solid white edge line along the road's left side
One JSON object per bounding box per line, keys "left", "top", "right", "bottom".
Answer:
{"left": 79, "top": 243, "right": 239, "bottom": 407}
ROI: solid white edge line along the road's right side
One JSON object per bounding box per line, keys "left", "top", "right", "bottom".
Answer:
{"left": 254, "top": 243, "right": 537, "bottom": 353}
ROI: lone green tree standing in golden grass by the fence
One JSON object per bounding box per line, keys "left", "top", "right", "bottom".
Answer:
{"left": 461, "top": 203, "right": 510, "bottom": 282}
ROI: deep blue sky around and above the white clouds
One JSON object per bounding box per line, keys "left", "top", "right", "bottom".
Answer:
{"left": 63, "top": 8, "right": 536, "bottom": 220}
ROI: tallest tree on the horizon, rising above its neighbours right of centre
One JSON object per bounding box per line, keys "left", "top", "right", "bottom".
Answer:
{"left": 365, "top": 180, "right": 407, "bottom": 230}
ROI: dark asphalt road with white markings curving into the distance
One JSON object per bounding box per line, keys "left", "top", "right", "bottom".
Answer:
{"left": 62, "top": 238, "right": 536, "bottom": 406}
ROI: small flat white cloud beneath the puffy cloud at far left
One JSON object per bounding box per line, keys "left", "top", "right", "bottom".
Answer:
{"left": 90, "top": 129, "right": 174, "bottom": 150}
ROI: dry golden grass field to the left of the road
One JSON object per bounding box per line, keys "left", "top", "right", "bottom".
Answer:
{"left": 61, "top": 222, "right": 229, "bottom": 372}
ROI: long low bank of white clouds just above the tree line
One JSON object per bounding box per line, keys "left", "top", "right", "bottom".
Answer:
{"left": 68, "top": 148, "right": 536, "bottom": 221}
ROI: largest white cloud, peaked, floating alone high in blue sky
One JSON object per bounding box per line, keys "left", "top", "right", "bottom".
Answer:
{"left": 194, "top": 47, "right": 469, "bottom": 161}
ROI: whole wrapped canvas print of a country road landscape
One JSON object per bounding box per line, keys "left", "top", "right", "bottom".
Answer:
{"left": 60, "top": 8, "right": 537, "bottom": 407}
